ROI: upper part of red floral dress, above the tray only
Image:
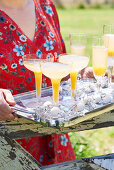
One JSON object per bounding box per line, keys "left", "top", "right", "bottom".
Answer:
{"left": 0, "top": 0, "right": 65, "bottom": 94}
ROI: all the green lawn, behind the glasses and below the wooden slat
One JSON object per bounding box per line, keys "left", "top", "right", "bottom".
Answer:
{"left": 57, "top": 8, "right": 114, "bottom": 158}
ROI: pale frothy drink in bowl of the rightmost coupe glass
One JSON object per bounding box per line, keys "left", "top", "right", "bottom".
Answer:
{"left": 59, "top": 54, "right": 89, "bottom": 72}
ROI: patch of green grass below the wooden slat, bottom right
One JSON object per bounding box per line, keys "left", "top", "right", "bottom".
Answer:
{"left": 69, "top": 127, "right": 114, "bottom": 159}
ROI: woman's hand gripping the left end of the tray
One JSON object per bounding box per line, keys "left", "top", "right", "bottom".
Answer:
{"left": 0, "top": 89, "right": 17, "bottom": 120}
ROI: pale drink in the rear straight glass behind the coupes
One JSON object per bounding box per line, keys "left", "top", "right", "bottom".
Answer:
{"left": 70, "top": 45, "right": 86, "bottom": 56}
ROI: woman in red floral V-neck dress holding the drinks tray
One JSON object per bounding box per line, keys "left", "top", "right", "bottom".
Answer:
{"left": 0, "top": 0, "right": 75, "bottom": 165}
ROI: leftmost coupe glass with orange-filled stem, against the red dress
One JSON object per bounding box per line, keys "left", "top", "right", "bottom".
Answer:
{"left": 23, "top": 54, "right": 44, "bottom": 99}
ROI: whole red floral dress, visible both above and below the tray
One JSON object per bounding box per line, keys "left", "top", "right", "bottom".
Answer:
{"left": 0, "top": 0, "right": 75, "bottom": 165}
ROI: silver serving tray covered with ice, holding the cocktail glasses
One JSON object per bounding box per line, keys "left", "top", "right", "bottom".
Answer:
{"left": 14, "top": 79, "right": 114, "bottom": 128}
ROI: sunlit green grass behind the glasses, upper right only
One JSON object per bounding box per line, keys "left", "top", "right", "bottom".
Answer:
{"left": 57, "top": 8, "right": 114, "bottom": 65}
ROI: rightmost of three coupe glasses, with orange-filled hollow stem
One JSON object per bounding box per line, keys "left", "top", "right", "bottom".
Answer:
{"left": 59, "top": 54, "right": 89, "bottom": 98}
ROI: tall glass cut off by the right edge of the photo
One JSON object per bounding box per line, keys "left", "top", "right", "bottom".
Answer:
{"left": 103, "top": 24, "right": 114, "bottom": 86}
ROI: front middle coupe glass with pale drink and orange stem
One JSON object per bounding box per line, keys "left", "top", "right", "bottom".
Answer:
{"left": 41, "top": 62, "right": 70, "bottom": 104}
